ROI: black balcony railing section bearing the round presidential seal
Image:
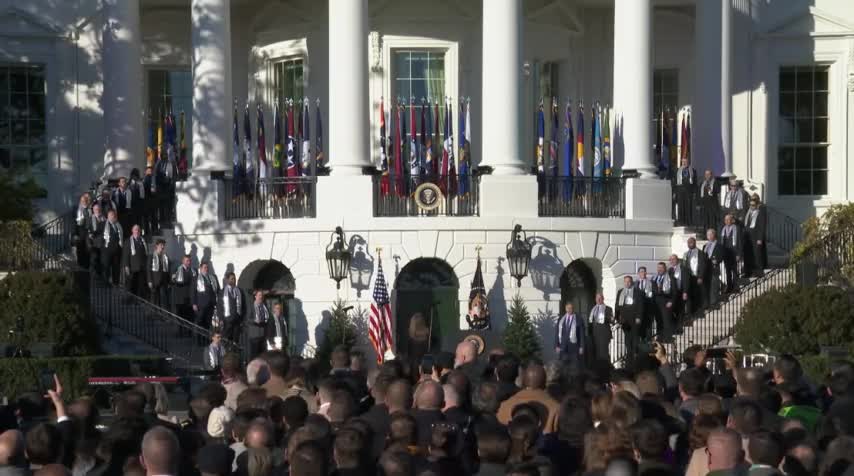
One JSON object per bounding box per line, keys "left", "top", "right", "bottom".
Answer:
{"left": 374, "top": 175, "right": 480, "bottom": 217}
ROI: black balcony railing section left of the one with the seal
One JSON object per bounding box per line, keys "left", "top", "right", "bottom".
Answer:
{"left": 224, "top": 177, "right": 317, "bottom": 220}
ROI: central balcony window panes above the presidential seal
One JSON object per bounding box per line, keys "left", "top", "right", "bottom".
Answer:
{"left": 394, "top": 49, "right": 447, "bottom": 137}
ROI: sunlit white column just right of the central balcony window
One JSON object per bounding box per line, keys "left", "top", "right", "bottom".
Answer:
{"left": 481, "top": 0, "right": 531, "bottom": 175}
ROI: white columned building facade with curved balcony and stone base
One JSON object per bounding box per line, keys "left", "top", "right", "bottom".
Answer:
{"left": 0, "top": 0, "right": 854, "bottom": 356}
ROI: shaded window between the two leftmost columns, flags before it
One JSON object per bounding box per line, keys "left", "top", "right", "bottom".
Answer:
{"left": 147, "top": 69, "right": 193, "bottom": 157}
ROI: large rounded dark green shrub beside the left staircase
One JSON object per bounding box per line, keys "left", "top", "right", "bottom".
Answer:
{"left": 0, "top": 271, "right": 100, "bottom": 357}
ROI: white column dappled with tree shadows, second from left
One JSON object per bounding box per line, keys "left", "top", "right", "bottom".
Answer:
{"left": 191, "top": 0, "right": 232, "bottom": 172}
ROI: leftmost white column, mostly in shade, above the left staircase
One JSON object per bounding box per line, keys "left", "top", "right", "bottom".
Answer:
{"left": 102, "top": 0, "right": 145, "bottom": 178}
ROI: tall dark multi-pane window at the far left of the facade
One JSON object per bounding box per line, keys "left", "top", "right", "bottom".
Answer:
{"left": 0, "top": 64, "right": 47, "bottom": 186}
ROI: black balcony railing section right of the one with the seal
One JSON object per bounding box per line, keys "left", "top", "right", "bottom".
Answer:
{"left": 538, "top": 177, "right": 626, "bottom": 218}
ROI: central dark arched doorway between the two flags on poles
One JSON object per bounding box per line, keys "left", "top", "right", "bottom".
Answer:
{"left": 394, "top": 258, "right": 460, "bottom": 363}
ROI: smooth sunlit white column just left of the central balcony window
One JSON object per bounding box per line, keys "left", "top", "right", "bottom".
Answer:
{"left": 327, "top": 0, "right": 371, "bottom": 175}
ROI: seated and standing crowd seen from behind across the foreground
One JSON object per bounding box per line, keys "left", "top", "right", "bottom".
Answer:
{"left": 5, "top": 341, "right": 854, "bottom": 476}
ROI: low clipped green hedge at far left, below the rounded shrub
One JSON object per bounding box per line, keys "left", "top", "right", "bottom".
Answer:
{"left": 0, "top": 355, "right": 167, "bottom": 400}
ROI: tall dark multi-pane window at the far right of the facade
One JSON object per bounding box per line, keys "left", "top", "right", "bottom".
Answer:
{"left": 777, "top": 65, "right": 830, "bottom": 195}
